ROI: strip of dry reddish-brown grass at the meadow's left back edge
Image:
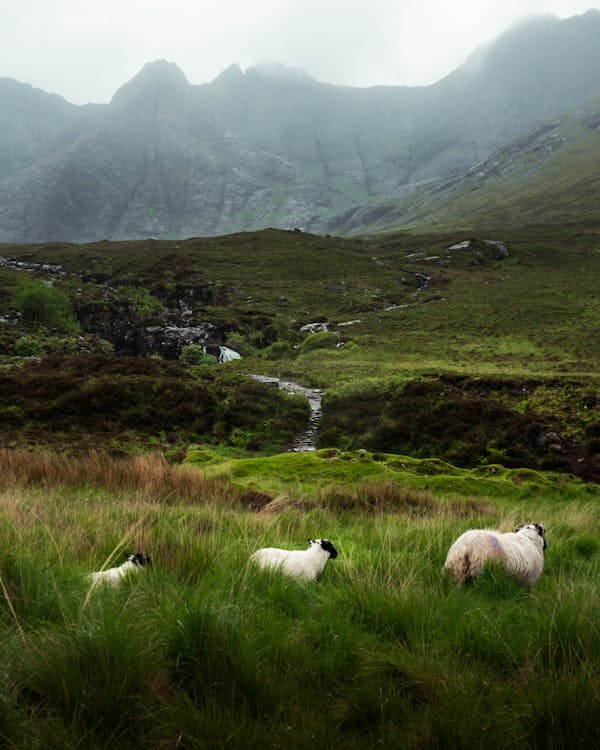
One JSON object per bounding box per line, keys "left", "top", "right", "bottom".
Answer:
{"left": 0, "top": 449, "right": 237, "bottom": 505}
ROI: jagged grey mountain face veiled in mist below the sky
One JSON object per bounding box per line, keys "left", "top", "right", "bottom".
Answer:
{"left": 0, "top": 12, "right": 600, "bottom": 242}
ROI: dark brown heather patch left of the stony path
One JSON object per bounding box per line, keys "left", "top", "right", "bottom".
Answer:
{"left": 0, "top": 354, "right": 309, "bottom": 454}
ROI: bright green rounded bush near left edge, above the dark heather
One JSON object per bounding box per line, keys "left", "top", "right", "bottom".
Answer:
{"left": 12, "top": 276, "right": 79, "bottom": 332}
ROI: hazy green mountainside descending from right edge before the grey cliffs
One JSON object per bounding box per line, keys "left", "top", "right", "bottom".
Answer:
{"left": 334, "top": 97, "right": 600, "bottom": 234}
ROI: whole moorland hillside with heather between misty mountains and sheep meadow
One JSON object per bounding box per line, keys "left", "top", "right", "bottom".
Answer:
{"left": 0, "top": 223, "right": 600, "bottom": 480}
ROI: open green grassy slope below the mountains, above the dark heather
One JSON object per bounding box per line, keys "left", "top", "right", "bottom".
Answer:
{"left": 2, "top": 225, "right": 600, "bottom": 378}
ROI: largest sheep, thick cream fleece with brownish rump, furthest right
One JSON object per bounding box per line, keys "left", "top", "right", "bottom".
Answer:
{"left": 444, "top": 523, "right": 548, "bottom": 586}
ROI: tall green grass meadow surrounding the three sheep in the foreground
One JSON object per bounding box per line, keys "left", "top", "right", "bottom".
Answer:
{"left": 0, "top": 451, "right": 600, "bottom": 750}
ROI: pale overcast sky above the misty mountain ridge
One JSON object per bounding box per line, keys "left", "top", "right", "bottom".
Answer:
{"left": 0, "top": 0, "right": 600, "bottom": 104}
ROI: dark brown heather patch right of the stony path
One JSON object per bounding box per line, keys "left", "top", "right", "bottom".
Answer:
{"left": 319, "top": 376, "right": 569, "bottom": 471}
